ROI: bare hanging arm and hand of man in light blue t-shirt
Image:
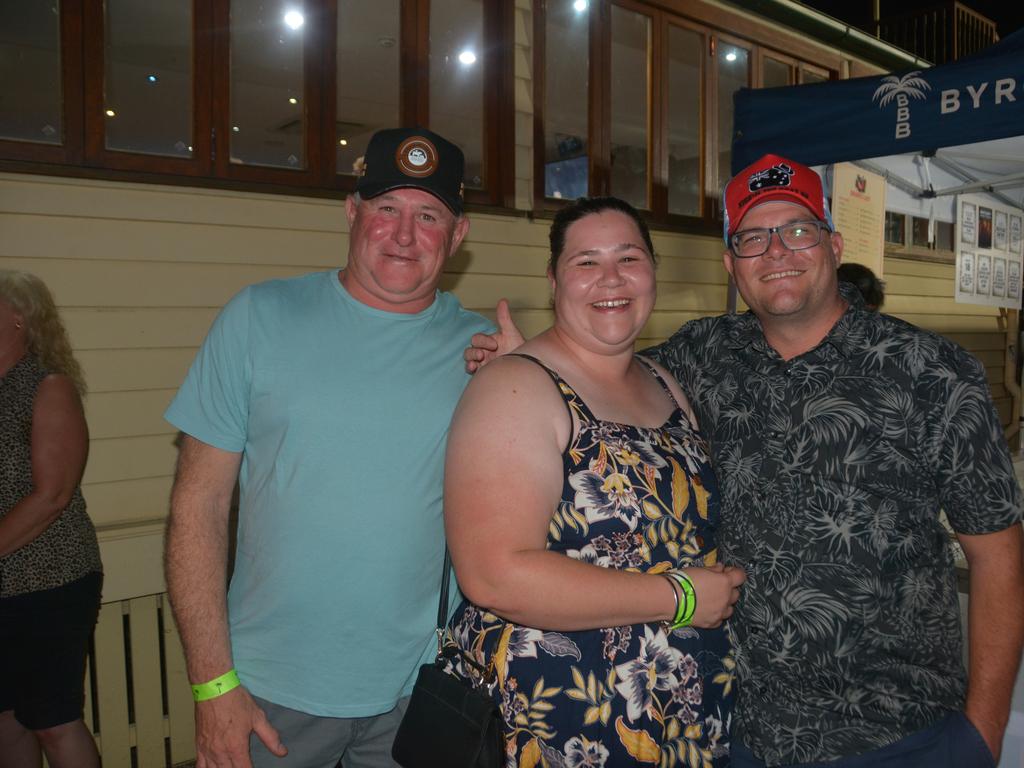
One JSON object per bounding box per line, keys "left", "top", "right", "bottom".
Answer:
{"left": 164, "top": 435, "right": 287, "bottom": 768}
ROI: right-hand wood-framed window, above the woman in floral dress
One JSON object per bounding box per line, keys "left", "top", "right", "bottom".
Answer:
{"left": 534, "top": 0, "right": 839, "bottom": 231}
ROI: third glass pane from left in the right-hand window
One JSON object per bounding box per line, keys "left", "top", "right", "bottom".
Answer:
{"left": 669, "top": 25, "right": 703, "bottom": 216}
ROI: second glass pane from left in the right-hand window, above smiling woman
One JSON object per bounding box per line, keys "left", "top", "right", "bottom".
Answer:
{"left": 610, "top": 5, "right": 650, "bottom": 208}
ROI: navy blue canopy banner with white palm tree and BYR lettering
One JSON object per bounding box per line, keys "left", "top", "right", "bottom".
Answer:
{"left": 732, "top": 30, "right": 1024, "bottom": 173}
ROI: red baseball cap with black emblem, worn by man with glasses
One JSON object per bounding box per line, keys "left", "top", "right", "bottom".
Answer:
{"left": 722, "top": 155, "right": 835, "bottom": 245}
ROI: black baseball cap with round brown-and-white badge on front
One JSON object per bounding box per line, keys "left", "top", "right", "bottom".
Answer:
{"left": 355, "top": 128, "right": 466, "bottom": 216}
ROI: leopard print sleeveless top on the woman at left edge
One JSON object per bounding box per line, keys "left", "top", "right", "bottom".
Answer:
{"left": 0, "top": 355, "right": 102, "bottom": 598}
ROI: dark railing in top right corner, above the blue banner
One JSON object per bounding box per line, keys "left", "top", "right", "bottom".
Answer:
{"left": 879, "top": 2, "right": 999, "bottom": 65}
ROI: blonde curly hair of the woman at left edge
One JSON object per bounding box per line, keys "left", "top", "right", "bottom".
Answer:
{"left": 0, "top": 269, "right": 86, "bottom": 397}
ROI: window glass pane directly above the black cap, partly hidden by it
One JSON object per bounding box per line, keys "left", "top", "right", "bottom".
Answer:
{"left": 334, "top": 0, "right": 401, "bottom": 175}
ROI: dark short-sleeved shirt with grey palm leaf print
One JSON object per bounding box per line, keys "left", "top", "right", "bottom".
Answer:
{"left": 645, "top": 285, "right": 1021, "bottom": 766}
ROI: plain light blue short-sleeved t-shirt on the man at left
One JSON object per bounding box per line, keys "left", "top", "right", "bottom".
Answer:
{"left": 165, "top": 270, "right": 492, "bottom": 717}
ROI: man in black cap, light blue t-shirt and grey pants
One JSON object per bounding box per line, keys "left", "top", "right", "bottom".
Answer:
{"left": 166, "top": 128, "right": 488, "bottom": 768}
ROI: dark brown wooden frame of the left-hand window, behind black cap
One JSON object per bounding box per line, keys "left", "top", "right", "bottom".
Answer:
{"left": 0, "top": 0, "right": 515, "bottom": 208}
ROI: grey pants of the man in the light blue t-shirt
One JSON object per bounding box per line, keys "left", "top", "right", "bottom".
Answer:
{"left": 249, "top": 696, "right": 409, "bottom": 768}
